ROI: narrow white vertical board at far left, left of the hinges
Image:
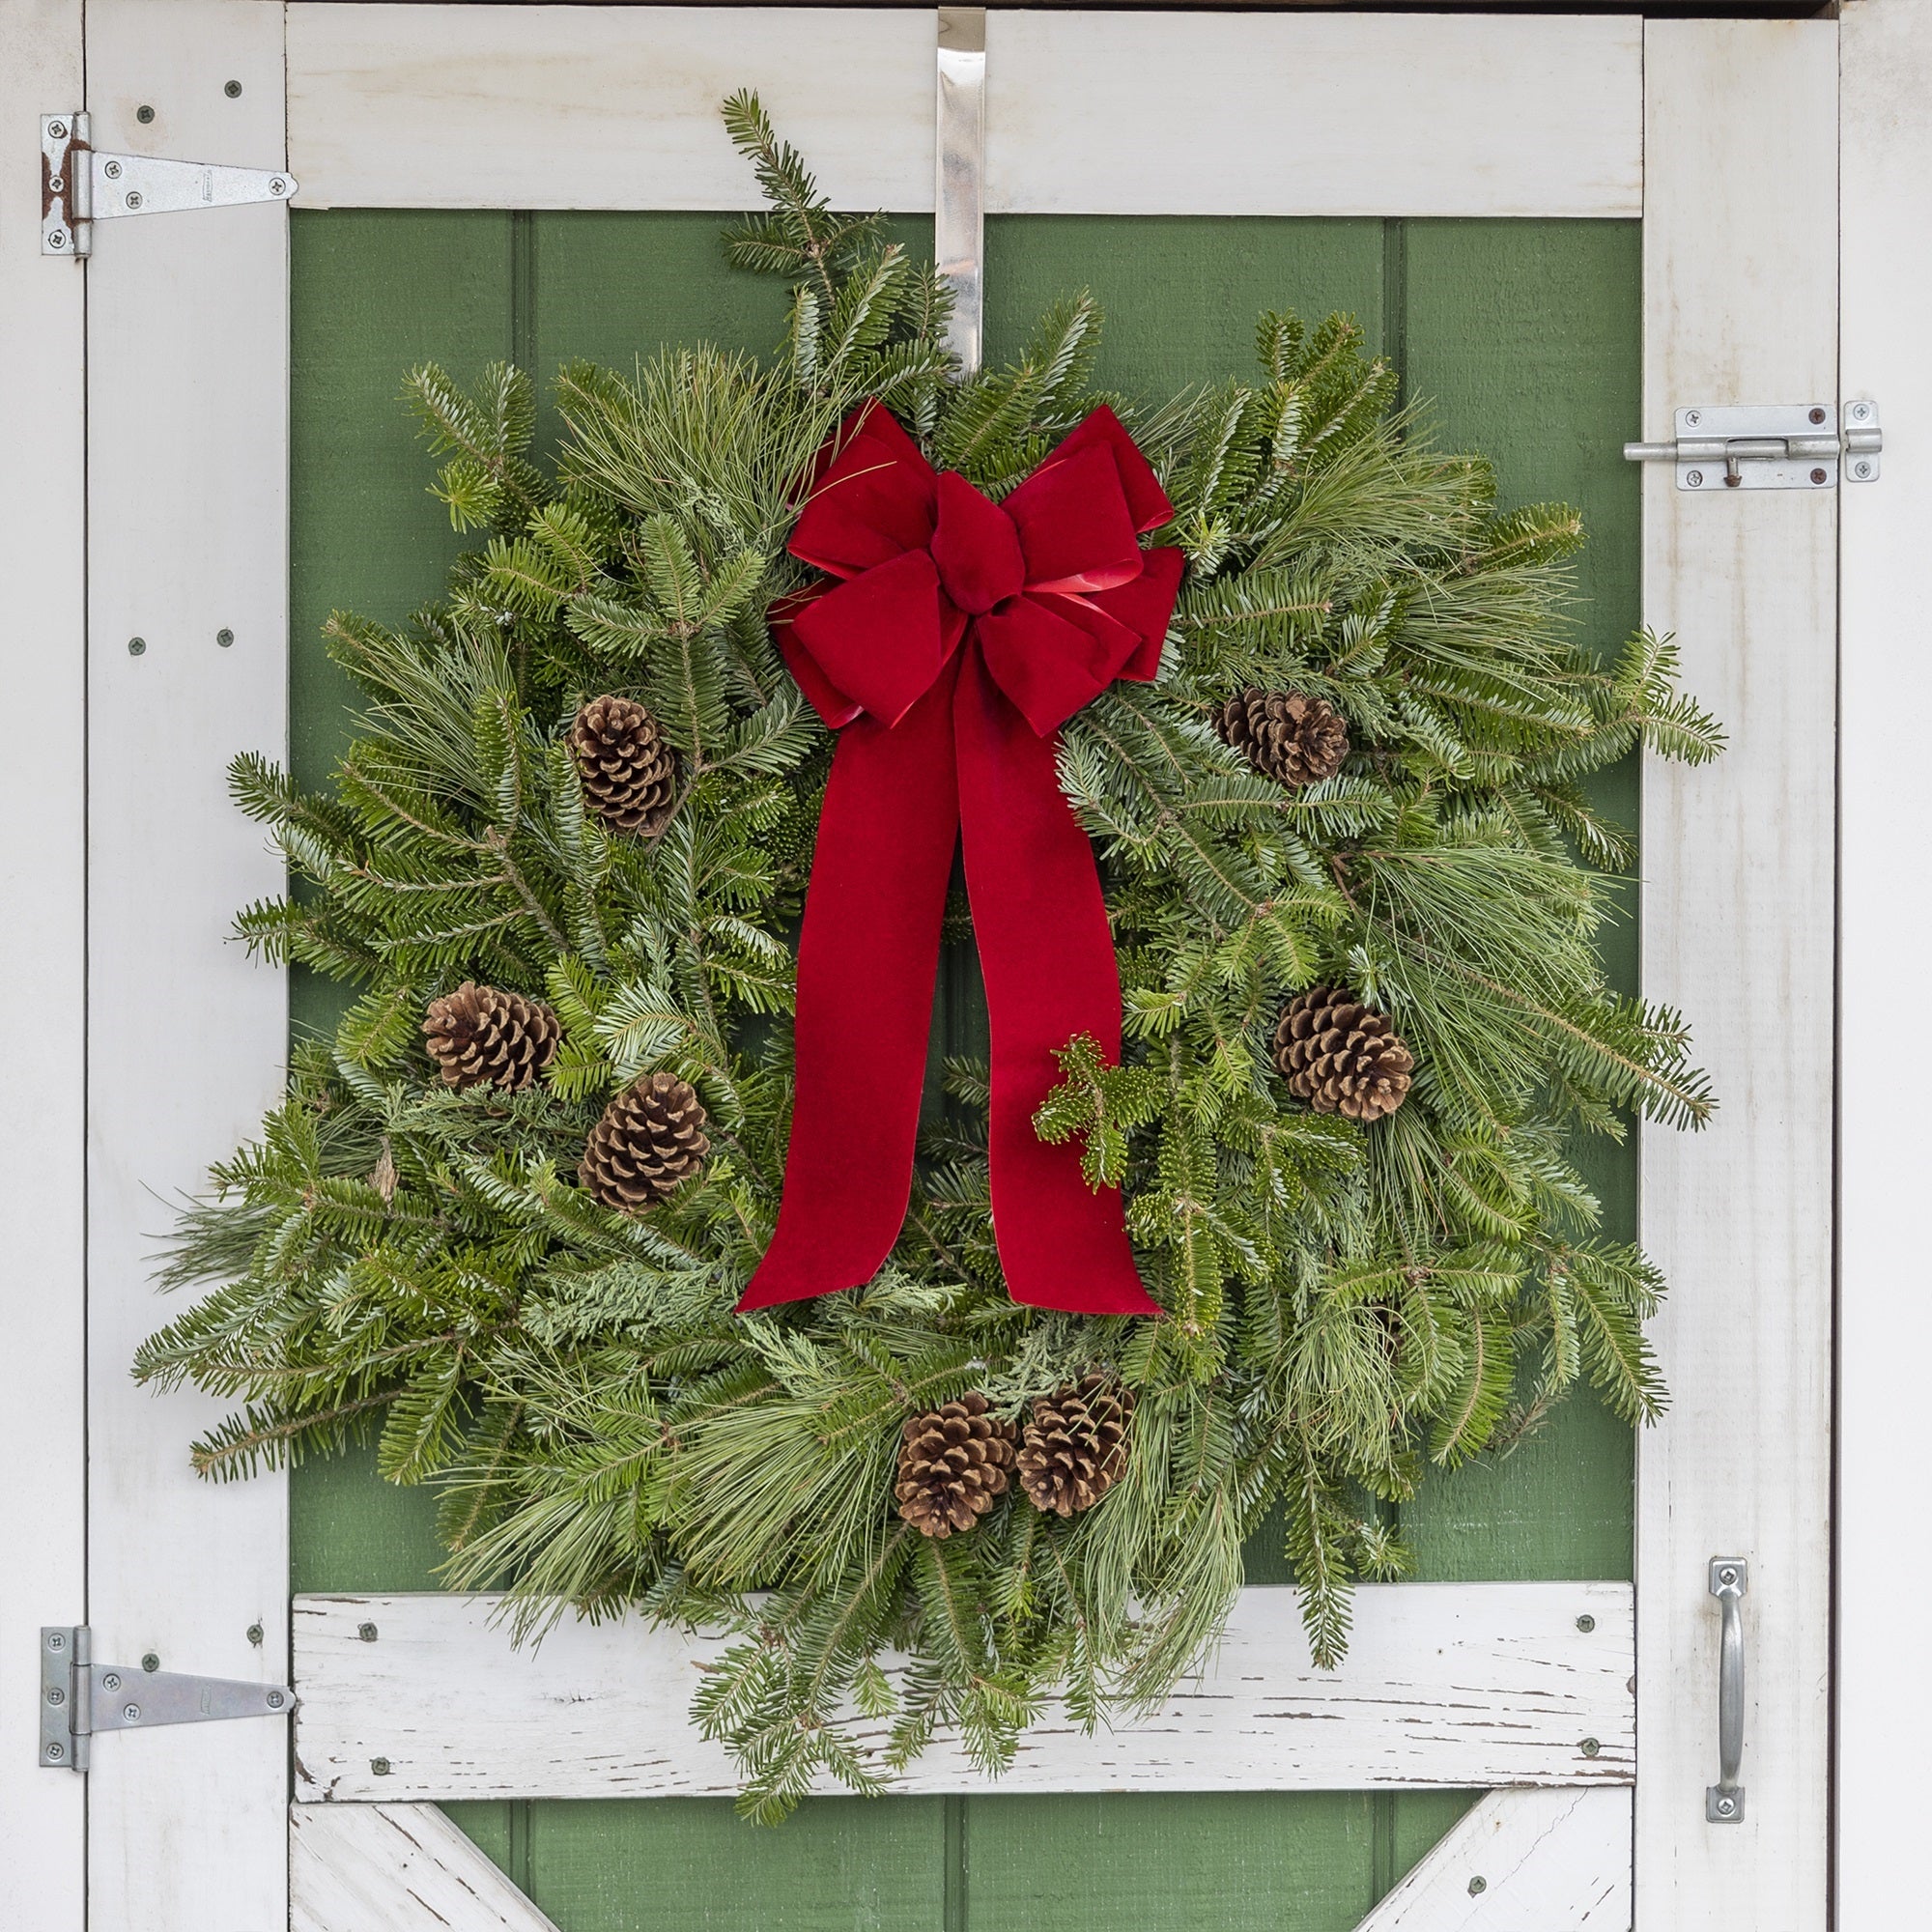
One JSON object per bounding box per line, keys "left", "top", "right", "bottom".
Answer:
{"left": 0, "top": 0, "right": 87, "bottom": 1932}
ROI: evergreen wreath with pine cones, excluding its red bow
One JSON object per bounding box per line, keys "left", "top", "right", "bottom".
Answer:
{"left": 137, "top": 95, "right": 1721, "bottom": 1818}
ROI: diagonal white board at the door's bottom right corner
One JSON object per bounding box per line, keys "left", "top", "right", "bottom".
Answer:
{"left": 1356, "top": 1787, "right": 1631, "bottom": 1932}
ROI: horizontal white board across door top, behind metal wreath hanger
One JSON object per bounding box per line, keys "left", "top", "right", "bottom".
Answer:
{"left": 288, "top": 0, "right": 1642, "bottom": 216}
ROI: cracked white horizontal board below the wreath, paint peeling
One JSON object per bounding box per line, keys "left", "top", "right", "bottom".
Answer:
{"left": 294, "top": 1582, "right": 1634, "bottom": 1803}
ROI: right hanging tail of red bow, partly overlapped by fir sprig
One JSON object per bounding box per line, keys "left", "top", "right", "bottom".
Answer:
{"left": 952, "top": 649, "right": 1161, "bottom": 1316}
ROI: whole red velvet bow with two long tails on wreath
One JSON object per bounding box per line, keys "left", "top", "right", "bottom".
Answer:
{"left": 738, "top": 402, "right": 1182, "bottom": 1314}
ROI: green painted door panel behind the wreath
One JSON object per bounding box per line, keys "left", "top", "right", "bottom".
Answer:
{"left": 290, "top": 211, "right": 1640, "bottom": 1932}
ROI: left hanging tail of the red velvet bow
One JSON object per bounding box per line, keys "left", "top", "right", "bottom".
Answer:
{"left": 738, "top": 667, "right": 958, "bottom": 1314}
